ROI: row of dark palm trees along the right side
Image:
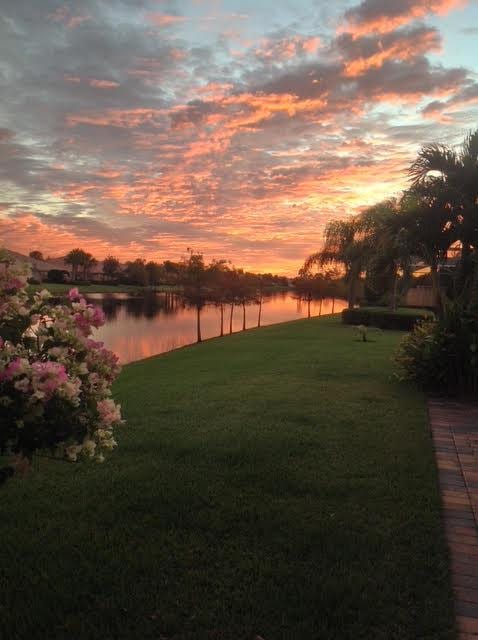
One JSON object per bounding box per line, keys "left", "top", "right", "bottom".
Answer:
{"left": 300, "top": 130, "right": 478, "bottom": 310}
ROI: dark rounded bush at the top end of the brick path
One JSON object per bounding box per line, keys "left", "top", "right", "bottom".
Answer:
{"left": 395, "top": 303, "right": 478, "bottom": 395}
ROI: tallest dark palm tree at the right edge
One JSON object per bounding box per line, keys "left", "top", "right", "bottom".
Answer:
{"left": 409, "top": 130, "right": 478, "bottom": 292}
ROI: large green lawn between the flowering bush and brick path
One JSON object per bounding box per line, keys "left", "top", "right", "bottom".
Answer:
{"left": 0, "top": 317, "right": 455, "bottom": 640}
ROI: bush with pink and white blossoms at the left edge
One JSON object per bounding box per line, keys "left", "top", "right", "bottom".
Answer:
{"left": 0, "top": 251, "right": 123, "bottom": 480}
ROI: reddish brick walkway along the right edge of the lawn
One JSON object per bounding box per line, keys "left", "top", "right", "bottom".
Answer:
{"left": 429, "top": 400, "right": 478, "bottom": 640}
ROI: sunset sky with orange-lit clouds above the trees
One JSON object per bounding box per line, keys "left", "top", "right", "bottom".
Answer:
{"left": 0, "top": 0, "right": 478, "bottom": 275}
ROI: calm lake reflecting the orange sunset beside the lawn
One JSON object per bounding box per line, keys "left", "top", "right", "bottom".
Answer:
{"left": 87, "top": 291, "right": 347, "bottom": 364}
